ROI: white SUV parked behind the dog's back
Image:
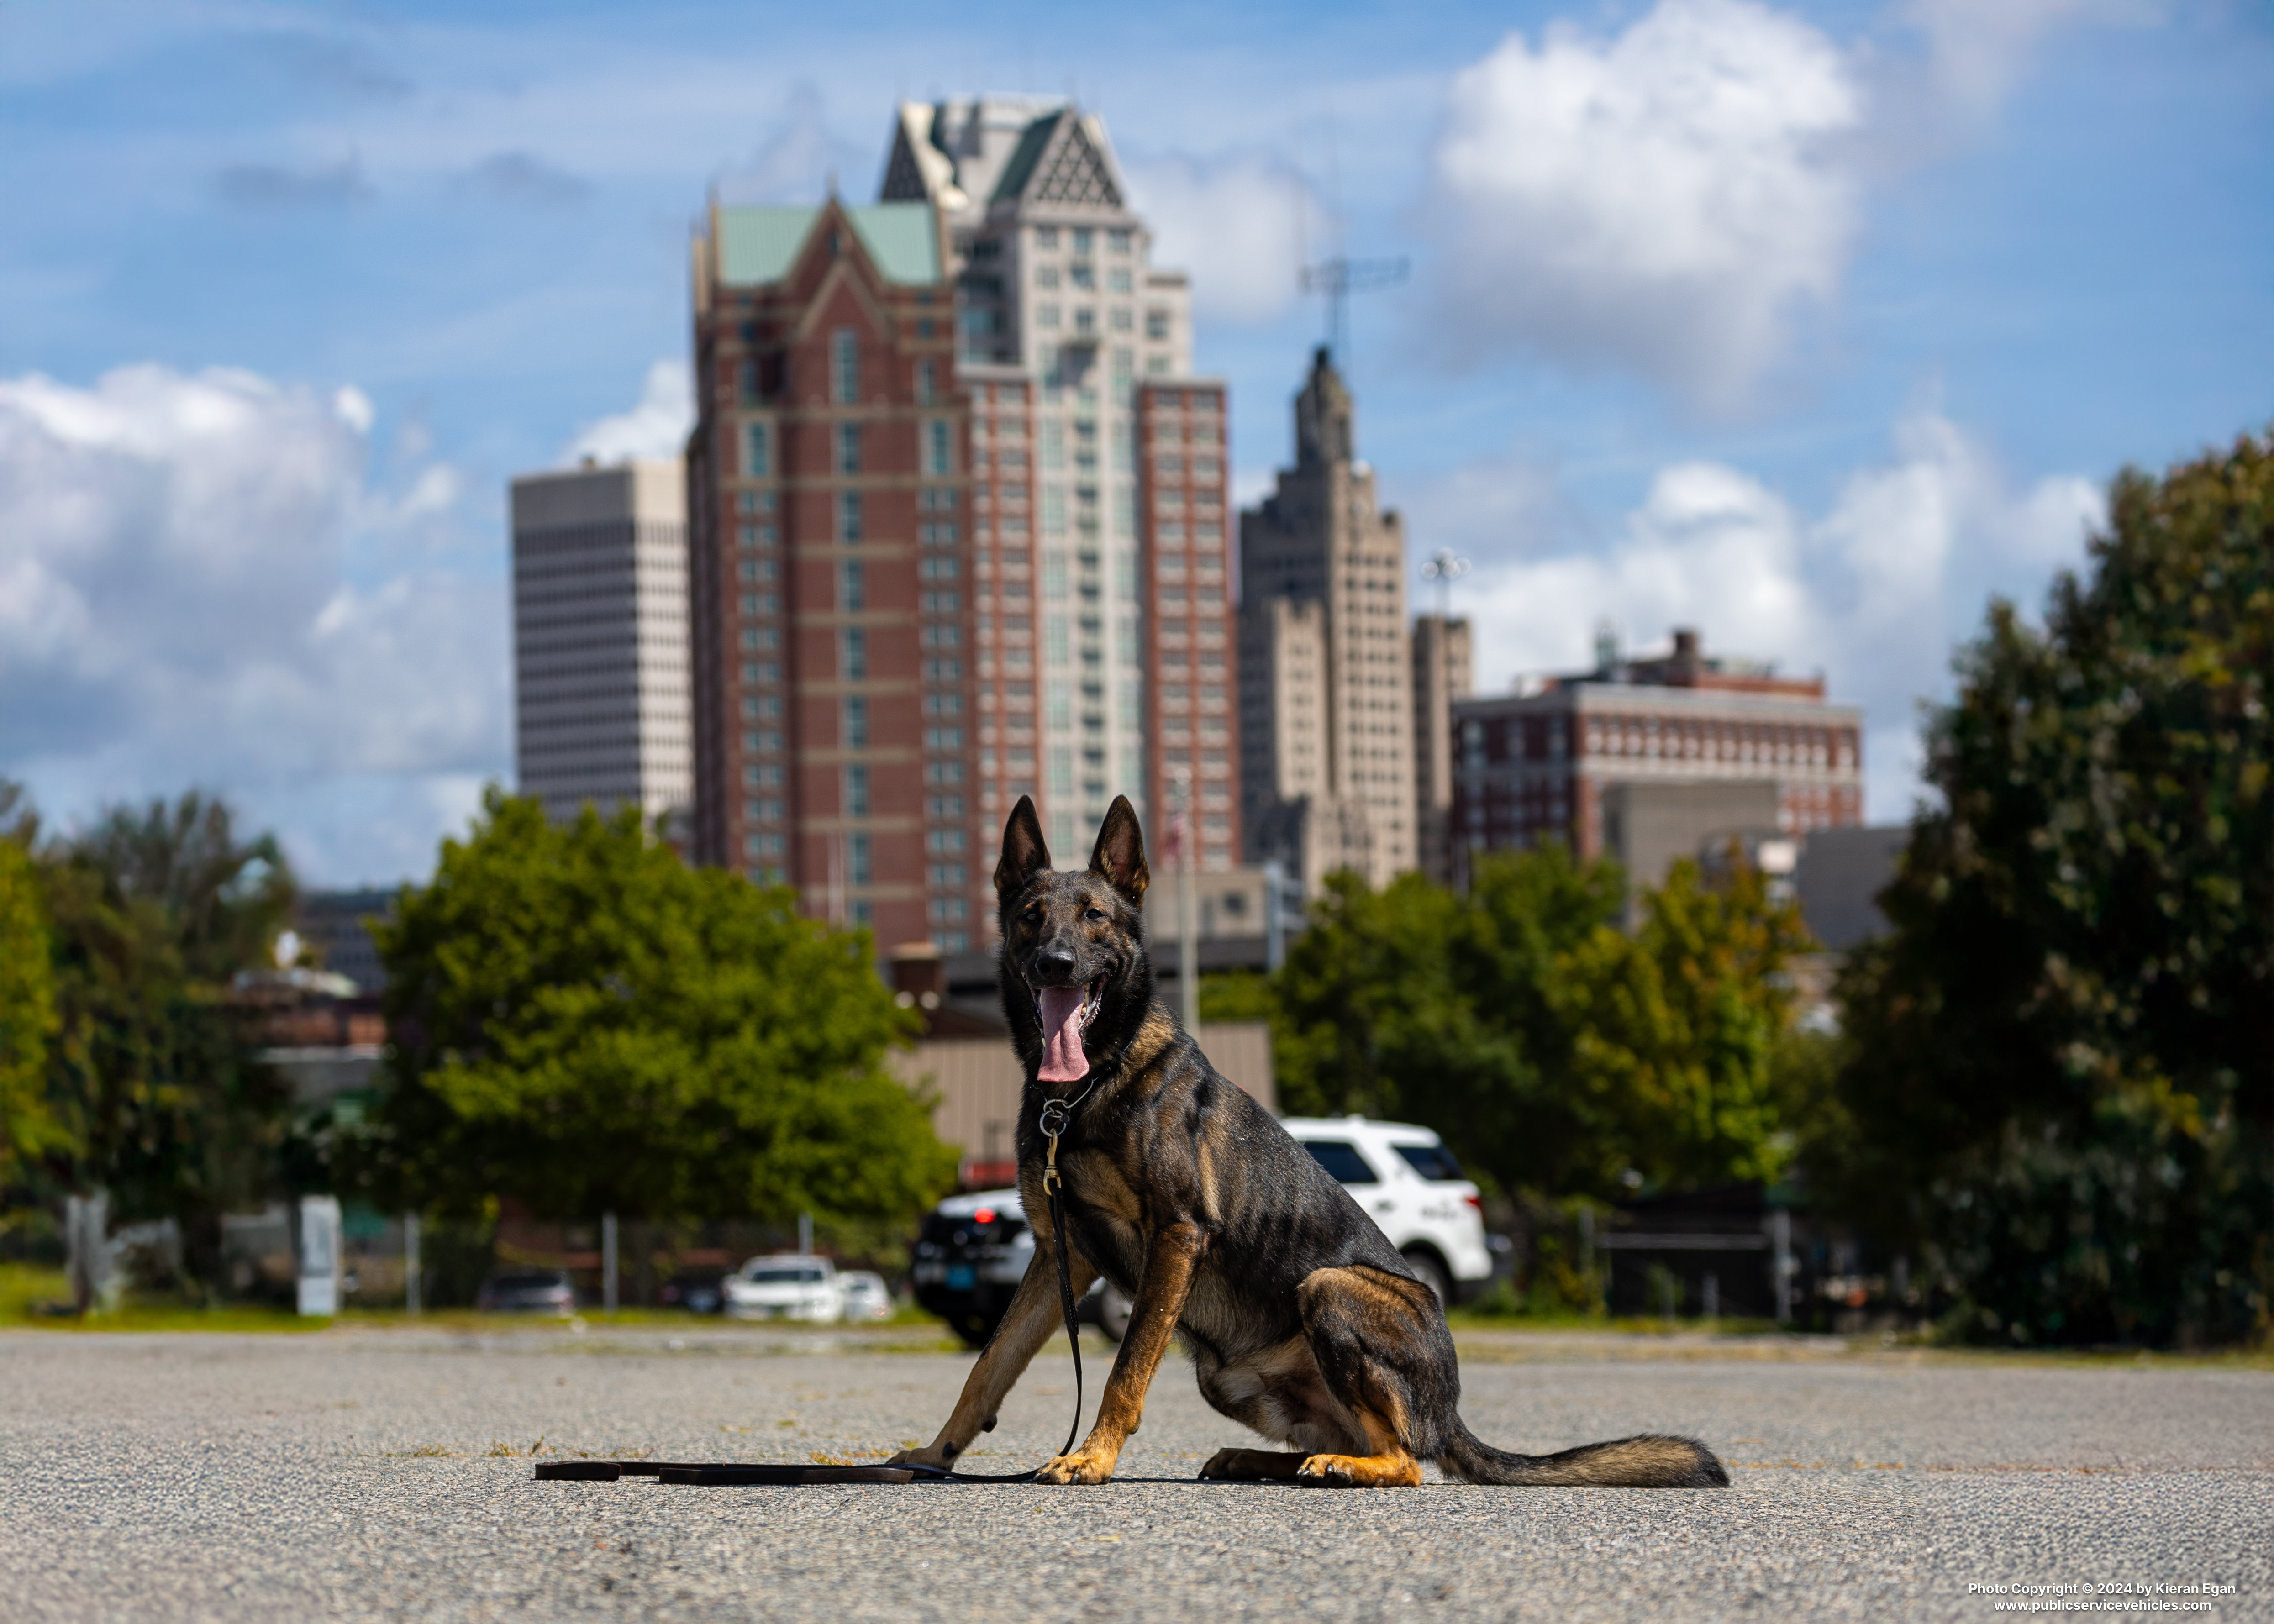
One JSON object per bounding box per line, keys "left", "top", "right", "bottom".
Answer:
{"left": 1280, "top": 1117, "right": 1492, "bottom": 1303}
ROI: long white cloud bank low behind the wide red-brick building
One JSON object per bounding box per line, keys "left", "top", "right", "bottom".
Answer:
{"left": 1417, "top": 412, "right": 2104, "bottom": 819}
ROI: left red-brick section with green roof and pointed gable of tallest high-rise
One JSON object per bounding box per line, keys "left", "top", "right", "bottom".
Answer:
{"left": 689, "top": 198, "right": 987, "bottom": 948}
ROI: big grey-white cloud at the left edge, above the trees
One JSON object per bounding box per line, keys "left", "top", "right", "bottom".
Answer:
{"left": 0, "top": 366, "right": 507, "bottom": 878}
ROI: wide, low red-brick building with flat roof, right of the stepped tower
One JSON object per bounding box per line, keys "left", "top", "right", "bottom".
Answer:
{"left": 1453, "top": 628, "right": 1863, "bottom": 885}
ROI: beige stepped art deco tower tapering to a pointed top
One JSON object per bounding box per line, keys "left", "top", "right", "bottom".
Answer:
{"left": 1239, "top": 348, "right": 1419, "bottom": 892}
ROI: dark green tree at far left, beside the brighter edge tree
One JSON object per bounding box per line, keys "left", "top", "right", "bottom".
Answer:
{"left": 41, "top": 794, "right": 293, "bottom": 1283}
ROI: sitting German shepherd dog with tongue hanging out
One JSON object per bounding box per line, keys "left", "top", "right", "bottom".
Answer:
{"left": 894, "top": 799, "right": 1728, "bottom": 1487}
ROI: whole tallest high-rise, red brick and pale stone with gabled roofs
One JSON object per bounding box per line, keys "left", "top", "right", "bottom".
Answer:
{"left": 689, "top": 100, "right": 1239, "bottom": 953}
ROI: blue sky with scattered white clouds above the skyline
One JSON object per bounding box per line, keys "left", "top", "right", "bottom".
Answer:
{"left": 0, "top": 0, "right": 2274, "bottom": 885}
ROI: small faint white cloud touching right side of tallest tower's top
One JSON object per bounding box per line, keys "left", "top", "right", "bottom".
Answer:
{"left": 1121, "top": 157, "right": 1312, "bottom": 321}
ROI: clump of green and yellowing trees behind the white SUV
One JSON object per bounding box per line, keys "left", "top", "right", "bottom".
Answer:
{"left": 1271, "top": 846, "right": 1808, "bottom": 1196}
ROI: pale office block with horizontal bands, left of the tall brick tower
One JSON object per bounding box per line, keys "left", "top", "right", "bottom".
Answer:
{"left": 512, "top": 462, "right": 694, "bottom": 821}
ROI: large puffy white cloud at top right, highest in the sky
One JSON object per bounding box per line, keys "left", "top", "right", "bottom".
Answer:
{"left": 1428, "top": 0, "right": 1865, "bottom": 407}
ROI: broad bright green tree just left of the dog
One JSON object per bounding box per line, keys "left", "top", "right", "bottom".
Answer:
{"left": 343, "top": 789, "right": 955, "bottom": 1219}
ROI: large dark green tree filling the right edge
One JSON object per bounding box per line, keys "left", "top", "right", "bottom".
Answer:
{"left": 1826, "top": 437, "right": 2274, "bottom": 1342}
